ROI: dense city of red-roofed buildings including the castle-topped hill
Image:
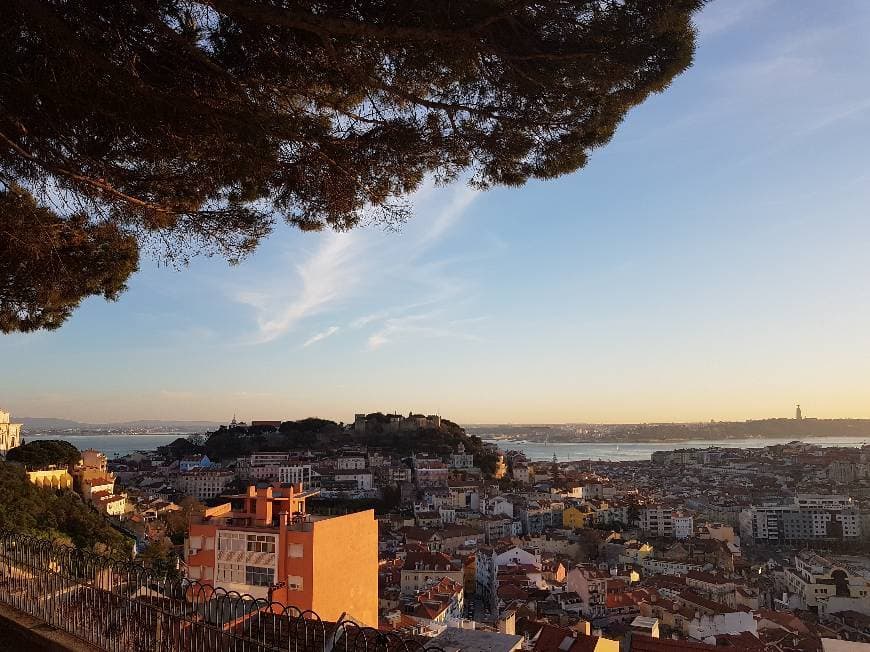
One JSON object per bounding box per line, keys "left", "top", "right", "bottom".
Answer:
{"left": 0, "top": 404, "right": 870, "bottom": 652}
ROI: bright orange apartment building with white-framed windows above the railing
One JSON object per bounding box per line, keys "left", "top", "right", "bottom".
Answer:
{"left": 185, "top": 484, "right": 378, "bottom": 627}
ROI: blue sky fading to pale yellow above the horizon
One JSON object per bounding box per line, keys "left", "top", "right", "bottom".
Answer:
{"left": 0, "top": 0, "right": 870, "bottom": 423}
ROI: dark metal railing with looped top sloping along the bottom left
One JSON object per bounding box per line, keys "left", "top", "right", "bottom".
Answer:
{"left": 0, "top": 531, "right": 439, "bottom": 652}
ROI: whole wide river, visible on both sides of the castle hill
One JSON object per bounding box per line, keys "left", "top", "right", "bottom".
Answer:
{"left": 24, "top": 434, "right": 870, "bottom": 462}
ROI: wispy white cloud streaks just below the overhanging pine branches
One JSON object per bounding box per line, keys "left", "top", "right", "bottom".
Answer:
{"left": 235, "top": 176, "right": 490, "bottom": 348}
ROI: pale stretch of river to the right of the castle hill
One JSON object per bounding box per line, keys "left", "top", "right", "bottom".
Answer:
{"left": 487, "top": 437, "right": 870, "bottom": 462}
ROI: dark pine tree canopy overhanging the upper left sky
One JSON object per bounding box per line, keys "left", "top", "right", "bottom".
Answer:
{"left": 0, "top": 0, "right": 703, "bottom": 332}
